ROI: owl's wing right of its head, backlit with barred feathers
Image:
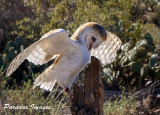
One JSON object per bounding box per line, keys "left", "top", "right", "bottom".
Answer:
{"left": 91, "top": 31, "right": 122, "bottom": 65}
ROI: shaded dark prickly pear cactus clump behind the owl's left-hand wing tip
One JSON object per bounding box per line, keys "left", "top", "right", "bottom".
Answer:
{"left": 0, "top": 38, "right": 39, "bottom": 86}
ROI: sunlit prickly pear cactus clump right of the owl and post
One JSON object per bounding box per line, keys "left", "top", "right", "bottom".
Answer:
{"left": 103, "top": 30, "right": 160, "bottom": 88}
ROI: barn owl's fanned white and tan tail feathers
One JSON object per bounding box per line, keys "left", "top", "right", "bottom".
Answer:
{"left": 33, "top": 65, "right": 57, "bottom": 91}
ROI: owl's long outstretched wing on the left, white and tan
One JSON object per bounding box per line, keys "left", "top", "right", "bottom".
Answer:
{"left": 6, "top": 29, "right": 74, "bottom": 77}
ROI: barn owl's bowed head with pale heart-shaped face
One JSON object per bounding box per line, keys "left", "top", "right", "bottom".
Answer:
{"left": 71, "top": 22, "right": 107, "bottom": 50}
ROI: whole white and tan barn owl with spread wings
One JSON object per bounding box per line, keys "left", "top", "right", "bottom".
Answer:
{"left": 6, "top": 22, "right": 122, "bottom": 92}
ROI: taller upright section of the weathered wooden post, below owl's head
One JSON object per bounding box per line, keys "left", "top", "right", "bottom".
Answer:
{"left": 84, "top": 57, "right": 104, "bottom": 115}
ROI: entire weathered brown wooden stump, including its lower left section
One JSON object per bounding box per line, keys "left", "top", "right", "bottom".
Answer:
{"left": 71, "top": 57, "right": 104, "bottom": 115}
